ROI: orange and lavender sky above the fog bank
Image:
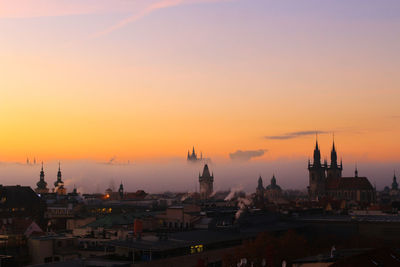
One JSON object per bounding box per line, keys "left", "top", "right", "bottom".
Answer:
{"left": 0, "top": 0, "right": 400, "bottom": 193}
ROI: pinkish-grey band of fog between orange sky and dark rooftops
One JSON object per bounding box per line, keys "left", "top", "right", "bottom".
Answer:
{"left": 0, "top": 141, "right": 398, "bottom": 193}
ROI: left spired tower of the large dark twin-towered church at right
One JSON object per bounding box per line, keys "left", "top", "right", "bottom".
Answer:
{"left": 308, "top": 139, "right": 327, "bottom": 200}
